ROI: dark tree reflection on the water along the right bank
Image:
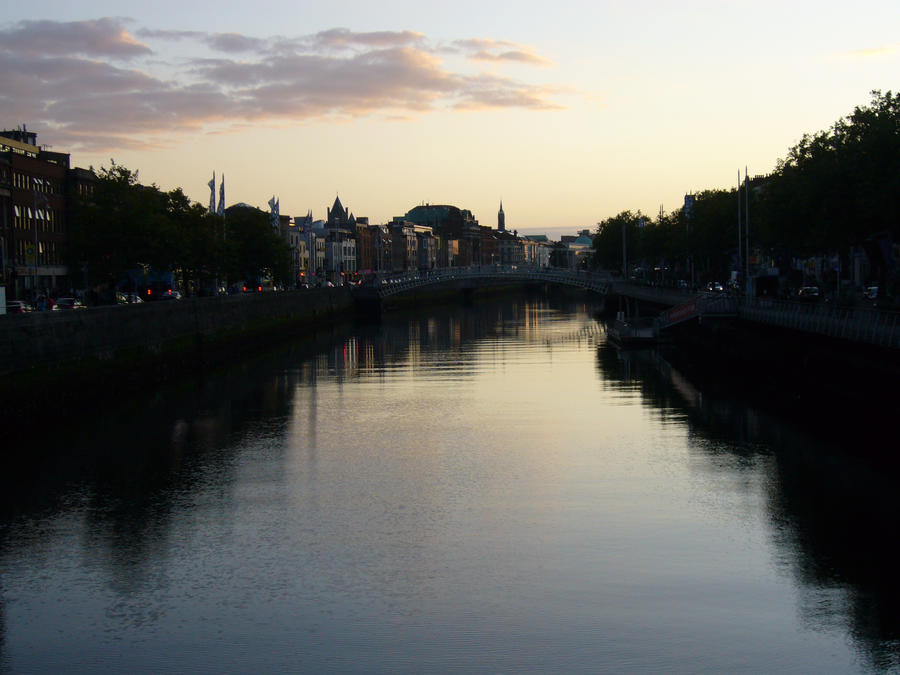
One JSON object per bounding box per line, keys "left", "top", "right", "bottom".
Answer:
{"left": 597, "top": 344, "right": 900, "bottom": 670}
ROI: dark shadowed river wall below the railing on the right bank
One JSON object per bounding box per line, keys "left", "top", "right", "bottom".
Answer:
{"left": 660, "top": 318, "right": 900, "bottom": 465}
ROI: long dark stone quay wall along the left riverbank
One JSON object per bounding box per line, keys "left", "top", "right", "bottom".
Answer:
{"left": 0, "top": 287, "right": 354, "bottom": 417}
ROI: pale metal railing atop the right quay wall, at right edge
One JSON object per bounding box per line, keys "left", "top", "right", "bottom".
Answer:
{"left": 738, "top": 298, "right": 900, "bottom": 349}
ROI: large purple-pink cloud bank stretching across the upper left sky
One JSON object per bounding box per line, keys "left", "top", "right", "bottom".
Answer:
{"left": 0, "top": 19, "right": 559, "bottom": 151}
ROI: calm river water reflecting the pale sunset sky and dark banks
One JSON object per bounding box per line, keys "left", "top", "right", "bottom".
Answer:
{"left": 0, "top": 297, "right": 900, "bottom": 673}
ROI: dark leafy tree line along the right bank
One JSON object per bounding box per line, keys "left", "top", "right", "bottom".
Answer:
{"left": 593, "top": 90, "right": 900, "bottom": 295}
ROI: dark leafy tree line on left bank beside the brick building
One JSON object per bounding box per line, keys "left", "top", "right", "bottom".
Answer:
{"left": 66, "top": 161, "right": 291, "bottom": 294}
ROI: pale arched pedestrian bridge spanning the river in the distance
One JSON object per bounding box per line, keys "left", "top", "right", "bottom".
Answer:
{"left": 369, "top": 265, "right": 610, "bottom": 299}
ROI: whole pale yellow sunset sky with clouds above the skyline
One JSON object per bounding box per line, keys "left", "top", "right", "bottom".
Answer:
{"left": 0, "top": 0, "right": 900, "bottom": 237}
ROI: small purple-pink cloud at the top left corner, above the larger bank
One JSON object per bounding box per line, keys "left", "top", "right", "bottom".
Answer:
{"left": 0, "top": 18, "right": 152, "bottom": 59}
